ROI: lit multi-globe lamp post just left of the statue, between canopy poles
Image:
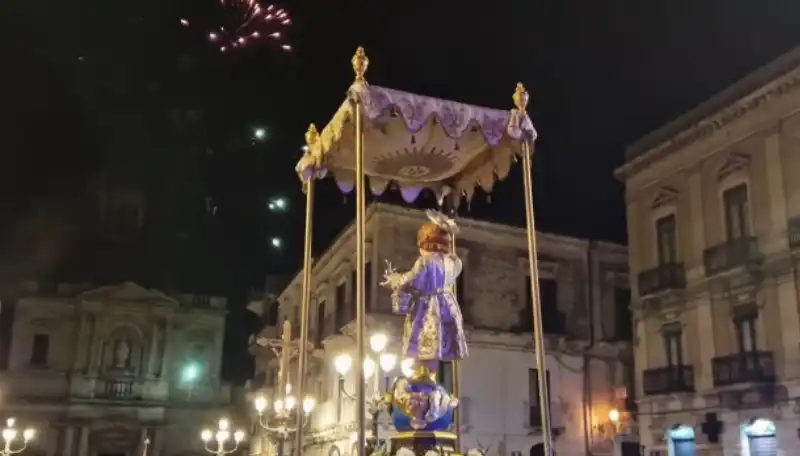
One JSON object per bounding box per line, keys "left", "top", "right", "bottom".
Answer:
{"left": 333, "top": 333, "right": 411, "bottom": 446}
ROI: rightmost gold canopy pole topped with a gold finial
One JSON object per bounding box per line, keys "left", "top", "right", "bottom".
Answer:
{"left": 512, "top": 83, "right": 553, "bottom": 456}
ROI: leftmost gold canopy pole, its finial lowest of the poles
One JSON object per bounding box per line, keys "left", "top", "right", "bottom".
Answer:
{"left": 294, "top": 124, "right": 319, "bottom": 456}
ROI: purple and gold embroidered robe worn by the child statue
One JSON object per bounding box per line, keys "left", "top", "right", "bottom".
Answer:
{"left": 392, "top": 252, "right": 467, "bottom": 361}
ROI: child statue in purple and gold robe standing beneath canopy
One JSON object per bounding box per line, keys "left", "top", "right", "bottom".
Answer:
{"left": 381, "top": 211, "right": 468, "bottom": 380}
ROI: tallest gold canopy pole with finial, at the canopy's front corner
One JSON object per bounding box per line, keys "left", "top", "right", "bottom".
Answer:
{"left": 351, "top": 47, "right": 369, "bottom": 456}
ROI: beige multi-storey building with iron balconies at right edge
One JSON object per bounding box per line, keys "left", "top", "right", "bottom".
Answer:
{"left": 617, "top": 48, "right": 800, "bottom": 456}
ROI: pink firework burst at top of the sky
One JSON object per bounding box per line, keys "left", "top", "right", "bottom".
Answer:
{"left": 180, "top": 0, "right": 292, "bottom": 52}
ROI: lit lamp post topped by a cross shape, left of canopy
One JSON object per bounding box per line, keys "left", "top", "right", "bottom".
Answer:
{"left": 253, "top": 321, "right": 317, "bottom": 456}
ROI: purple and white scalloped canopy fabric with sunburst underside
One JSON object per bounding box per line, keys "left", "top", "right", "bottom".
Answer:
{"left": 296, "top": 81, "right": 536, "bottom": 202}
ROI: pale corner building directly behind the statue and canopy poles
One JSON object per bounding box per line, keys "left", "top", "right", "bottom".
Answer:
{"left": 251, "top": 204, "right": 632, "bottom": 456}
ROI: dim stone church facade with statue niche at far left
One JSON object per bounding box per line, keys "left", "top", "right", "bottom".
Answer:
{"left": 0, "top": 282, "right": 236, "bottom": 456}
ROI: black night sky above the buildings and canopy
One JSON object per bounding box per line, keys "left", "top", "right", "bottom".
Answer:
{"left": 0, "top": 0, "right": 800, "bottom": 376}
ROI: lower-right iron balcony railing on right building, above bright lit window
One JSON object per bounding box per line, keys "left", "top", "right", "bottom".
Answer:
{"left": 711, "top": 351, "right": 775, "bottom": 386}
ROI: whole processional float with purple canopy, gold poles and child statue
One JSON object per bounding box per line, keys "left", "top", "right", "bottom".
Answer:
{"left": 295, "top": 48, "right": 553, "bottom": 456}
